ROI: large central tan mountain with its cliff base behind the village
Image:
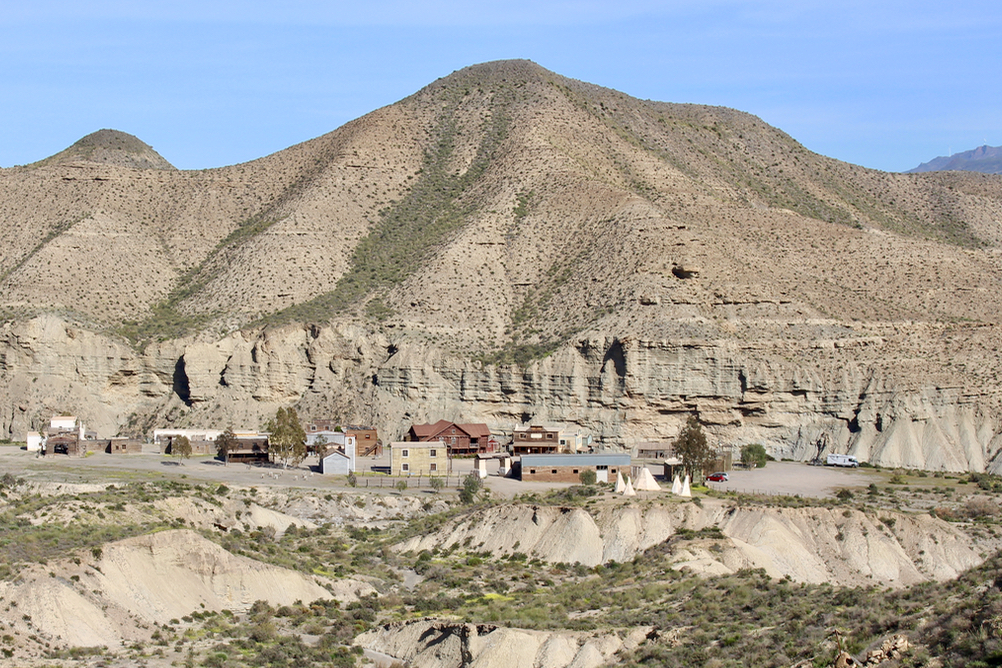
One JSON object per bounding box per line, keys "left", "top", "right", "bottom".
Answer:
{"left": 0, "top": 61, "right": 1002, "bottom": 471}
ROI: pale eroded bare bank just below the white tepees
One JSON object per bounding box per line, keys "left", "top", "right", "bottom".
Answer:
{"left": 396, "top": 501, "right": 998, "bottom": 587}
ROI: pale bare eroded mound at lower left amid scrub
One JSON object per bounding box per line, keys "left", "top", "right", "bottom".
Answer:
{"left": 0, "top": 530, "right": 366, "bottom": 647}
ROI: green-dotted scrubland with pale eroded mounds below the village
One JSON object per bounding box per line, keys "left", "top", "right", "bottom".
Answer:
{"left": 0, "top": 455, "right": 1002, "bottom": 668}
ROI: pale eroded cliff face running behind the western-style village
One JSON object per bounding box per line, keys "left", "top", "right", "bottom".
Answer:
{"left": 0, "top": 315, "right": 1002, "bottom": 472}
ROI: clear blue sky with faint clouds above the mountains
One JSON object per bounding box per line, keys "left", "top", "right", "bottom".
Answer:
{"left": 0, "top": 0, "right": 1002, "bottom": 171}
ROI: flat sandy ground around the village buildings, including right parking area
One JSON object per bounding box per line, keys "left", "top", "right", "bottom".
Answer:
{"left": 0, "top": 446, "right": 882, "bottom": 498}
